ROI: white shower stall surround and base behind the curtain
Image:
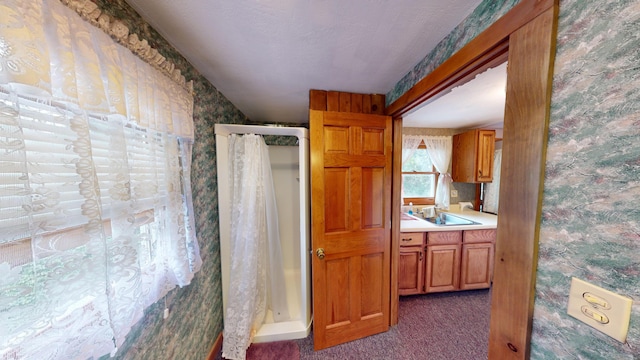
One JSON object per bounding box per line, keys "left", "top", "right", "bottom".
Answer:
{"left": 215, "top": 124, "right": 312, "bottom": 343}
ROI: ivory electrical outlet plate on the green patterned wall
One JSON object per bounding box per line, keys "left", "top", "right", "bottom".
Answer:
{"left": 567, "top": 277, "right": 632, "bottom": 343}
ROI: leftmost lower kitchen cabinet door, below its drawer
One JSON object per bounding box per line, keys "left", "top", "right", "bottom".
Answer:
{"left": 398, "top": 246, "right": 424, "bottom": 295}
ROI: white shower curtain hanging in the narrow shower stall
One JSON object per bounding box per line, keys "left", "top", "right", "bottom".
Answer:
{"left": 222, "top": 134, "right": 289, "bottom": 360}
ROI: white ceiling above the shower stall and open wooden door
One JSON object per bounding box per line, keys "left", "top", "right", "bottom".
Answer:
{"left": 126, "top": 0, "right": 504, "bottom": 127}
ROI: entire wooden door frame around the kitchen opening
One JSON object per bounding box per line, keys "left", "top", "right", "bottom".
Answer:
{"left": 386, "top": 0, "right": 558, "bottom": 359}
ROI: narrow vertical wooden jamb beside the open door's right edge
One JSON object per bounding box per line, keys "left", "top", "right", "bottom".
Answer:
{"left": 389, "top": 118, "right": 402, "bottom": 326}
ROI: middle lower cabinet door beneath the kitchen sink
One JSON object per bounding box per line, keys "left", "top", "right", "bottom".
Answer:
{"left": 425, "top": 244, "right": 460, "bottom": 293}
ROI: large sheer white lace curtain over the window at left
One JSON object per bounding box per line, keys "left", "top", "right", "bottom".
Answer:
{"left": 0, "top": 0, "right": 202, "bottom": 359}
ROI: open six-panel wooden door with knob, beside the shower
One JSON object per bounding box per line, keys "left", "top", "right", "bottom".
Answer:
{"left": 309, "top": 110, "right": 392, "bottom": 350}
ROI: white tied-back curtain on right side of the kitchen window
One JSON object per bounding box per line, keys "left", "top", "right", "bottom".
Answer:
{"left": 423, "top": 136, "right": 453, "bottom": 209}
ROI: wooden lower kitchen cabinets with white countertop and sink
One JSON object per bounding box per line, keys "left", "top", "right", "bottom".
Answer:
{"left": 398, "top": 210, "right": 498, "bottom": 295}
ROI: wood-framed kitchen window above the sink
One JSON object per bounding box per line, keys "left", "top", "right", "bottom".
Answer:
{"left": 402, "top": 142, "right": 438, "bottom": 205}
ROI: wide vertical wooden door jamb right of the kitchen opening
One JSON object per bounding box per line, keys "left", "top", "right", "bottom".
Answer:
{"left": 489, "top": 7, "right": 558, "bottom": 359}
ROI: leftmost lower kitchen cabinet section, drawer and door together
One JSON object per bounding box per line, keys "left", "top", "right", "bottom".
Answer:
{"left": 398, "top": 232, "right": 425, "bottom": 295}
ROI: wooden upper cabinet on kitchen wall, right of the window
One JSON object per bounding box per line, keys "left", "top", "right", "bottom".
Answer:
{"left": 451, "top": 129, "right": 496, "bottom": 183}
